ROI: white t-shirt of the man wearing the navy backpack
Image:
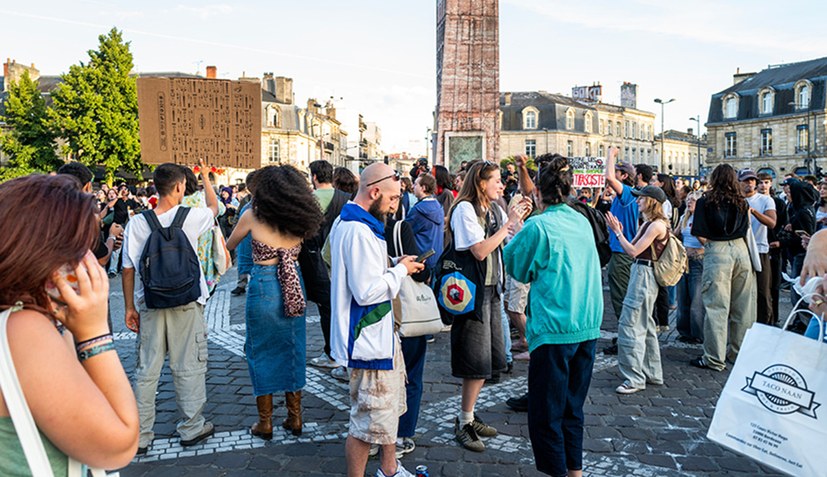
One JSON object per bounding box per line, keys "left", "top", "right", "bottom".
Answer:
{"left": 123, "top": 205, "right": 215, "bottom": 305}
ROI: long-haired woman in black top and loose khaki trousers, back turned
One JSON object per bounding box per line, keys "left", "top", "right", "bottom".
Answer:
{"left": 689, "top": 164, "right": 758, "bottom": 371}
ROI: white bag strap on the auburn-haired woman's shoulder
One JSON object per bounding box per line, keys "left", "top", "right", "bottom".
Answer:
{"left": 0, "top": 309, "right": 54, "bottom": 477}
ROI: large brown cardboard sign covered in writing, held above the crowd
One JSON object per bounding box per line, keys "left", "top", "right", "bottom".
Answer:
{"left": 138, "top": 78, "right": 261, "bottom": 169}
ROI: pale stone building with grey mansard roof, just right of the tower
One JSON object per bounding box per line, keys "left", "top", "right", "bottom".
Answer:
{"left": 499, "top": 87, "right": 655, "bottom": 166}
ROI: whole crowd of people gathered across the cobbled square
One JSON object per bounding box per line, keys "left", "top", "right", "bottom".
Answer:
{"left": 0, "top": 148, "right": 827, "bottom": 477}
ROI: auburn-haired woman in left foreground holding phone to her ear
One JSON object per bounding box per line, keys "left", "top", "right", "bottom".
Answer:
{"left": 0, "top": 175, "right": 138, "bottom": 475}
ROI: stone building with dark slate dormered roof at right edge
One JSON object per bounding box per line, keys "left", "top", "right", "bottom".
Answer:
{"left": 706, "top": 58, "right": 827, "bottom": 176}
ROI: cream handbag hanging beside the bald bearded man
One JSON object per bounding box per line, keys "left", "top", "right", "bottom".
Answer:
{"left": 393, "top": 220, "right": 442, "bottom": 338}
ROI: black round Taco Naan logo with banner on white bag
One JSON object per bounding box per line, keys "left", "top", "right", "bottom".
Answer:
{"left": 741, "top": 364, "right": 821, "bottom": 419}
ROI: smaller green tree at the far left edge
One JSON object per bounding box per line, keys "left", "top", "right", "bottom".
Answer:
{"left": 0, "top": 71, "right": 62, "bottom": 180}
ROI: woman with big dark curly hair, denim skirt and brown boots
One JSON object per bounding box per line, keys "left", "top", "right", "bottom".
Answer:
{"left": 227, "top": 166, "right": 322, "bottom": 440}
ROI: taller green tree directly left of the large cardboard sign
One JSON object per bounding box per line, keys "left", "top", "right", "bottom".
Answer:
{"left": 50, "top": 28, "right": 143, "bottom": 182}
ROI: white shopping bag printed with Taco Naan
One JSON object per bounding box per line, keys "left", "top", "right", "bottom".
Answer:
{"left": 707, "top": 314, "right": 827, "bottom": 476}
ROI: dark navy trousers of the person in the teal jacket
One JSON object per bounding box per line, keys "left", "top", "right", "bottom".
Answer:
{"left": 528, "top": 340, "right": 597, "bottom": 476}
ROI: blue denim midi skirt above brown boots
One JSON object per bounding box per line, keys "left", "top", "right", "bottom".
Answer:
{"left": 249, "top": 265, "right": 307, "bottom": 396}
